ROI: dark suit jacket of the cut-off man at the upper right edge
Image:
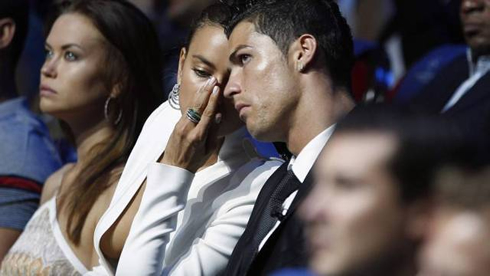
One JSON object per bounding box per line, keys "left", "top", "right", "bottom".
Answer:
{"left": 411, "top": 55, "right": 490, "bottom": 159}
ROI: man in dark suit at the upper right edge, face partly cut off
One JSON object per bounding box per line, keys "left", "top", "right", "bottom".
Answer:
{"left": 411, "top": 0, "right": 490, "bottom": 157}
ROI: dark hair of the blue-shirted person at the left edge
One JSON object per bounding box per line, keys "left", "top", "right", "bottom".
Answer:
{"left": 0, "top": 0, "right": 29, "bottom": 66}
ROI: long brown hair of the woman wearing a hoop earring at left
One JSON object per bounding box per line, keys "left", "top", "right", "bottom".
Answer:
{"left": 47, "top": 0, "right": 163, "bottom": 244}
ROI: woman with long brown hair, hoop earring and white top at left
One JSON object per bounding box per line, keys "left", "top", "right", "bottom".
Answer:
{"left": 0, "top": 0, "right": 162, "bottom": 275}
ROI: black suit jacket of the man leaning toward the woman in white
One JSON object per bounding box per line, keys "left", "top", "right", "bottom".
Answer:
{"left": 223, "top": 163, "right": 313, "bottom": 276}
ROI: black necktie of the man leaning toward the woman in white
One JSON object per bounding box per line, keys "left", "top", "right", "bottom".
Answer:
{"left": 249, "top": 170, "right": 301, "bottom": 262}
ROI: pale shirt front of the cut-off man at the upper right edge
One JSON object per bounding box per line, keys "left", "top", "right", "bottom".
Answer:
{"left": 441, "top": 49, "right": 490, "bottom": 113}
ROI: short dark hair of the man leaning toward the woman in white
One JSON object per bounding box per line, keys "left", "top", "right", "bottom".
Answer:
{"left": 227, "top": 0, "right": 354, "bottom": 90}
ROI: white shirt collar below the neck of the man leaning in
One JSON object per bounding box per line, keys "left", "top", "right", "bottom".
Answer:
{"left": 288, "top": 125, "right": 335, "bottom": 183}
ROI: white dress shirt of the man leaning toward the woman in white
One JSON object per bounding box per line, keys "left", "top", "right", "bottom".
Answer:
{"left": 259, "top": 125, "right": 335, "bottom": 251}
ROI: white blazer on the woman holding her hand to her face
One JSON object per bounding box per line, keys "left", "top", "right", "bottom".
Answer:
{"left": 87, "top": 102, "right": 282, "bottom": 275}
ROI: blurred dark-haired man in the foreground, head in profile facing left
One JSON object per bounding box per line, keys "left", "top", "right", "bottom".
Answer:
{"left": 300, "top": 105, "right": 466, "bottom": 276}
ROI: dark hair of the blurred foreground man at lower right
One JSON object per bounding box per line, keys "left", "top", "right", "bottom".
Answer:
{"left": 333, "top": 104, "right": 474, "bottom": 203}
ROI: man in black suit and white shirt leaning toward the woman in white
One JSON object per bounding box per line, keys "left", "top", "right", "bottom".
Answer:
{"left": 224, "top": 0, "right": 354, "bottom": 275}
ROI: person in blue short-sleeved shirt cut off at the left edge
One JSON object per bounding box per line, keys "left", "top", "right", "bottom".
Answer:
{"left": 0, "top": 0, "right": 61, "bottom": 261}
